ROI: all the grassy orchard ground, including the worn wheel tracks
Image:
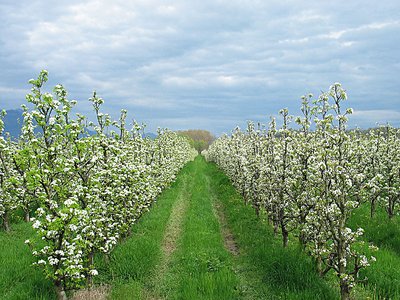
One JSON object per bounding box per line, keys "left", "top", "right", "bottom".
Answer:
{"left": 0, "top": 156, "right": 400, "bottom": 299}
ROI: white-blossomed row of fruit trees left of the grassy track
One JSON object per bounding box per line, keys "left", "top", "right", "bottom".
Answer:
{"left": 0, "top": 71, "right": 197, "bottom": 299}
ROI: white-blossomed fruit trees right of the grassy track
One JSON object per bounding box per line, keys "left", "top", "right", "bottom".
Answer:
{"left": 205, "top": 84, "right": 400, "bottom": 299}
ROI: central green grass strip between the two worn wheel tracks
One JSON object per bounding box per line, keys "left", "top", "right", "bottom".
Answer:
{"left": 160, "top": 156, "right": 240, "bottom": 299}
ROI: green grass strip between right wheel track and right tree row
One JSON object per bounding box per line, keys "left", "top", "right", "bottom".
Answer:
{"left": 205, "top": 159, "right": 339, "bottom": 299}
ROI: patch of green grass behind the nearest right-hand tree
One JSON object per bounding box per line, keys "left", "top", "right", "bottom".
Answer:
{"left": 349, "top": 204, "right": 400, "bottom": 299}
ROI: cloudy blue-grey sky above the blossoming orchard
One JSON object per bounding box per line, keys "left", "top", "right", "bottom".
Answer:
{"left": 0, "top": 0, "right": 400, "bottom": 135}
